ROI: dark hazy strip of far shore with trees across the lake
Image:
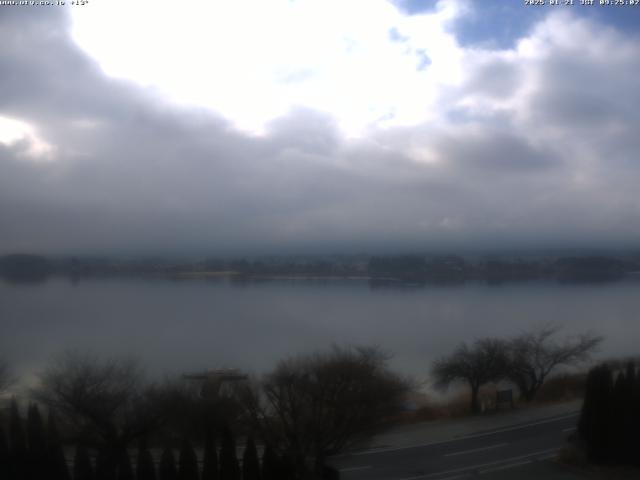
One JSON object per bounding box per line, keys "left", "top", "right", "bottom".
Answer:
{"left": 0, "top": 254, "right": 640, "bottom": 284}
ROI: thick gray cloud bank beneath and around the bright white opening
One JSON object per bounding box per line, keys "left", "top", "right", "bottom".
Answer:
{"left": 0, "top": 8, "right": 640, "bottom": 253}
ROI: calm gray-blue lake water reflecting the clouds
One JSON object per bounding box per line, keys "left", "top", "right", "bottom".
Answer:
{"left": 0, "top": 278, "right": 640, "bottom": 390}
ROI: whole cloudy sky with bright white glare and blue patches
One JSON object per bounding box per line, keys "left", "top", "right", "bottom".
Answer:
{"left": 0, "top": 0, "right": 640, "bottom": 255}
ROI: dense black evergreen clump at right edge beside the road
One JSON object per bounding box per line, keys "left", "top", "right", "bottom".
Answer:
{"left": 578, "top": 362, "right": 640, "bottom": 465}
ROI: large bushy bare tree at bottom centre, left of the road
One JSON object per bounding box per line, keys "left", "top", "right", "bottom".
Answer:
{"left": 244, "top": 347, "right": 410, "bottom": 473}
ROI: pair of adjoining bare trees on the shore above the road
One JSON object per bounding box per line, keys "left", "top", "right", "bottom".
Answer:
{"left": 432, "top": 326, "right": 602, "bottom": 413}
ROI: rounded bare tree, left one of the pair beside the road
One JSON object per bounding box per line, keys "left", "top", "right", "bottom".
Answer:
{"left": 432, "top": 338, "right": 507, "bottom": 413}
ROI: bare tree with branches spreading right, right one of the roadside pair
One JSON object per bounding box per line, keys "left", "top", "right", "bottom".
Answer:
{"left": 507, "top": 325, "right": 602, "bottom": 402}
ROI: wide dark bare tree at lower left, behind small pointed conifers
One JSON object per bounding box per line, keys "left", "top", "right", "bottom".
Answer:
{"left": 34, "top": 352, "right": 159, "bottom": 452}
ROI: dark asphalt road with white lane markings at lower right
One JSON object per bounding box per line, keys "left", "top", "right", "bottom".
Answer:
{"left": 330, "top": 413, "right": 578, "bottom": 480}
